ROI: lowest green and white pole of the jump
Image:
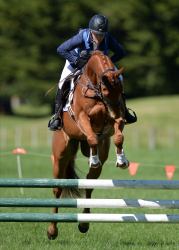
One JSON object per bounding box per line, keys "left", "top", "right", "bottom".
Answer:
{"left": 0, "top": 213, "right": 179, "bottom": 223}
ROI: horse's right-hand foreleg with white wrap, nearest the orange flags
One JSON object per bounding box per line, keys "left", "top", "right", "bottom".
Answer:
{"left": 113, "top": 118, "right": 129, "bottom": 169}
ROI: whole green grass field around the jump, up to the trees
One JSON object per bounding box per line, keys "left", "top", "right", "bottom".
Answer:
{"left": 0, "top": 96, "right": 179, "bottom": 250}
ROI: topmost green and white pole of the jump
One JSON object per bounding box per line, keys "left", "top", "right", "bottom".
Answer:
{"left": 0, "top": 178, "right": 179, "bottom": 189}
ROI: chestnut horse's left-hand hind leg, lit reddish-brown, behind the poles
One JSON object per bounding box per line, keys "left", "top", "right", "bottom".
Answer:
{"left": 47, "top": 130, "right": 78, "bottom": 240}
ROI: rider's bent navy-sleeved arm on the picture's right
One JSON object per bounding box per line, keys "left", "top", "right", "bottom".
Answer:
{"left": 108, "top": 34, "right": 126, "bottom": 63}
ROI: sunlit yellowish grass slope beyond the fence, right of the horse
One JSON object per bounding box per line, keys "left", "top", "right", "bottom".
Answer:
{"left": 124, "top": 95, "right": 179, "bottom": 148}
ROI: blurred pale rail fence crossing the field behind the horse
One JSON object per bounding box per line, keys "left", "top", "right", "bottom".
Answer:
{"left": 0, "top": 126, "right": 176, "bottom": 149}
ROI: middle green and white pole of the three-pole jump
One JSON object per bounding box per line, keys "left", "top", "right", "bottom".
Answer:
{"left": 0, "top": 198, "right": 179, "bottom": 209}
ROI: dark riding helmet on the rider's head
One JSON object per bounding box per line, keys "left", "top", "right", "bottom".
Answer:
{"left": 89, "top": 15, "right": 109, "bottom": 35}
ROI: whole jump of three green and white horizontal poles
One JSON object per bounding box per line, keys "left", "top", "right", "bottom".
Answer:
{"left": 0, "top": 179, "right": 179, "bottom": 223}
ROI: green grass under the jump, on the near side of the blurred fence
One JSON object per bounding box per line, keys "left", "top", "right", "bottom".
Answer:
{"left": 0, "top": 146, "right": 179, "bottom": 250}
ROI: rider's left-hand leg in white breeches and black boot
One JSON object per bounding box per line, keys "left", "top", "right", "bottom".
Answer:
{"left": 48, "top": 60, "right": 74, "bottom": 131}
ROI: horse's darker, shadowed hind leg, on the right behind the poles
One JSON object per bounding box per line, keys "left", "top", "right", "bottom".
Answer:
{"left": 78, "top": 138, "right": 110, "bottom": 233}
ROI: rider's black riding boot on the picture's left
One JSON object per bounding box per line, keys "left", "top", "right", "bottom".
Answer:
{"left": 48, "top": 87, "right": 63, "bottom": 131}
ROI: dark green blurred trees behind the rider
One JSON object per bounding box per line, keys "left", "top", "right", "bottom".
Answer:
{"left": 0, "top": 0, "right": 179, "bottom": 111}
